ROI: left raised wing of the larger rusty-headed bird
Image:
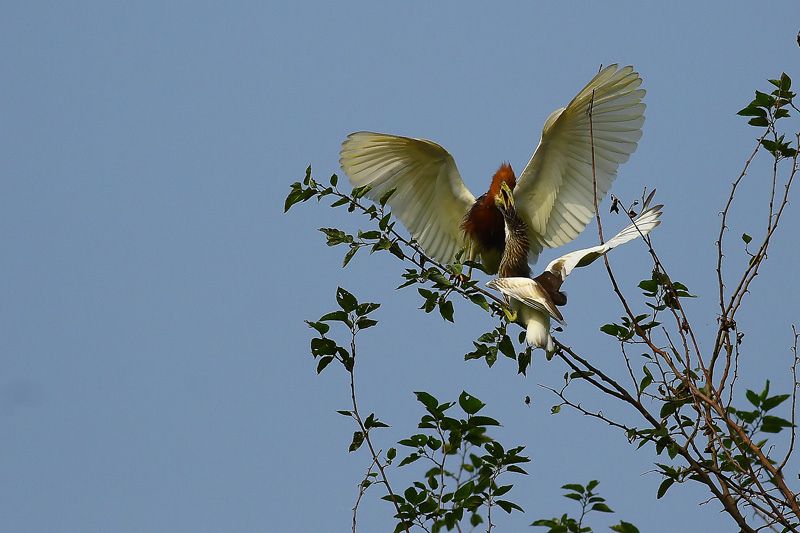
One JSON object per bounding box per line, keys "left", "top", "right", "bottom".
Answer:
{"left": 339, "top": 131, "right": 475, "bottom": 263}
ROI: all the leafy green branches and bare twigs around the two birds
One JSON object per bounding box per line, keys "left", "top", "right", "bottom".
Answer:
{"left": 285, "top": 74, "right": 800, "bottom": 533}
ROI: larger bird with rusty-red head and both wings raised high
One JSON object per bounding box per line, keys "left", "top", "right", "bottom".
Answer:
{"left": 339, "top": 65, "right": 645, "bottom": 274}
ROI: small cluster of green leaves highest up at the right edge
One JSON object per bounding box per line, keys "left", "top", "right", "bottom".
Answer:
{"left": 738, "top": 72, "right": 797, "bottom": 160}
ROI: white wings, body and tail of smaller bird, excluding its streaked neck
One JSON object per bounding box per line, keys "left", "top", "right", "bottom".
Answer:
{"left": 486, "top": 194, "right": 663, "bottom": 353}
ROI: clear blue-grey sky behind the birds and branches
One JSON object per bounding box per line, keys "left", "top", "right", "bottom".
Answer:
{"left": 0, "top": 1, "right": 800, "bottom": 532}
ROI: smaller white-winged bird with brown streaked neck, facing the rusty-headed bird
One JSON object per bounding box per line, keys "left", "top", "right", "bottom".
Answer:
{"left": 486, "top": 185, "right": 663, "bottom": 353}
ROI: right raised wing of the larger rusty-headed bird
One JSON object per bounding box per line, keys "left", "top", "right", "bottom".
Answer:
{"left": 514, "top": 65, "right": 645, "bottom": 259}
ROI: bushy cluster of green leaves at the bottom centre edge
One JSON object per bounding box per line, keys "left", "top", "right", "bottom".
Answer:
{"left": 390, "top": 392, "right": 530, "bottom": 533}
